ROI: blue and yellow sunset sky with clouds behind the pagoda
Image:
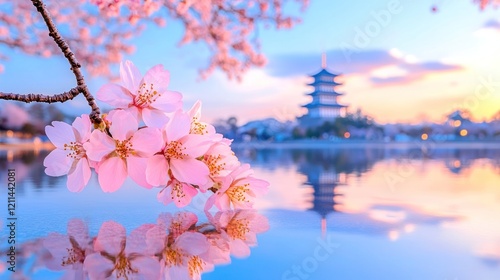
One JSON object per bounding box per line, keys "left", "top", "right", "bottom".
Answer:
{"left": 0, "top": 0, "right": 500, "bottom": 124}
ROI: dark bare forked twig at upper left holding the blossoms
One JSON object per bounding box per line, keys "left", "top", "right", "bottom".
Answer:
{"left": 0, "top": 0, "right": 102, "bottom": 125}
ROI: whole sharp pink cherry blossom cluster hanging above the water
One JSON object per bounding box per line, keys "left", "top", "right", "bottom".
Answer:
{"left": 44, "top": 61, "right": 268, "bottom": 210}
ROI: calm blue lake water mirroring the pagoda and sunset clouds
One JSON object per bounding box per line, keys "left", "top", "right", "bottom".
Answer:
{"left": 0, "top": 145, "right": 500, "bottom": 280}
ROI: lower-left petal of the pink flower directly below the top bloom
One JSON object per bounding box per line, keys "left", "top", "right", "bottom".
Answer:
{"left": 98, "top": 157, "right": 127, "bottom": 192}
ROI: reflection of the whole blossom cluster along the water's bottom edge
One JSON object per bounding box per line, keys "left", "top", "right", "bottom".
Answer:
{"left": 6, "top": 210, "right": 269, "bottom": 280}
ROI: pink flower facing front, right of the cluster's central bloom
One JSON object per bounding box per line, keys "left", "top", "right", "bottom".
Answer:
{"left": 146, "top": 111, "right": 212, "bottom": 188}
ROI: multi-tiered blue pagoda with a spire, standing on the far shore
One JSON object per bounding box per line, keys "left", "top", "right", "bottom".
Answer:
{"left": 299, "top": 54, "right": 347, "bottom": 126}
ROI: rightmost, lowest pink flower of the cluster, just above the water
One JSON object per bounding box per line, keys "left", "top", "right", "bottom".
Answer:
{"left": 205, "top": 164, "right": 269, "bottom": 210}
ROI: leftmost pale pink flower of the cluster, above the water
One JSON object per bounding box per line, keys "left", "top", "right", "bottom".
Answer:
{"left": 43, "top": 115, "right": 91, "bottom": 192}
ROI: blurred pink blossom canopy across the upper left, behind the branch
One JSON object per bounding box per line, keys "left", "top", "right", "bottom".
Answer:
{"left": 0, "top": 0, "right": 308, "bottom": 78}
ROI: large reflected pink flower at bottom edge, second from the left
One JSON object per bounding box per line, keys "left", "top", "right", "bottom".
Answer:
{"left": 84, "top": 221, "right": 161, "bottom": 280}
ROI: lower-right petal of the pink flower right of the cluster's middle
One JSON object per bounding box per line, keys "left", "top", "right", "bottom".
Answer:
{"left": 170, "top": 158, "right": 210, "bottom": 185}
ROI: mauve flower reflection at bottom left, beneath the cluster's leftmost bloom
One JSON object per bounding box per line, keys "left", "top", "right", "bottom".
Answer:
{"left": 43, "top": 219, "right": 93, "bottom": 280}
